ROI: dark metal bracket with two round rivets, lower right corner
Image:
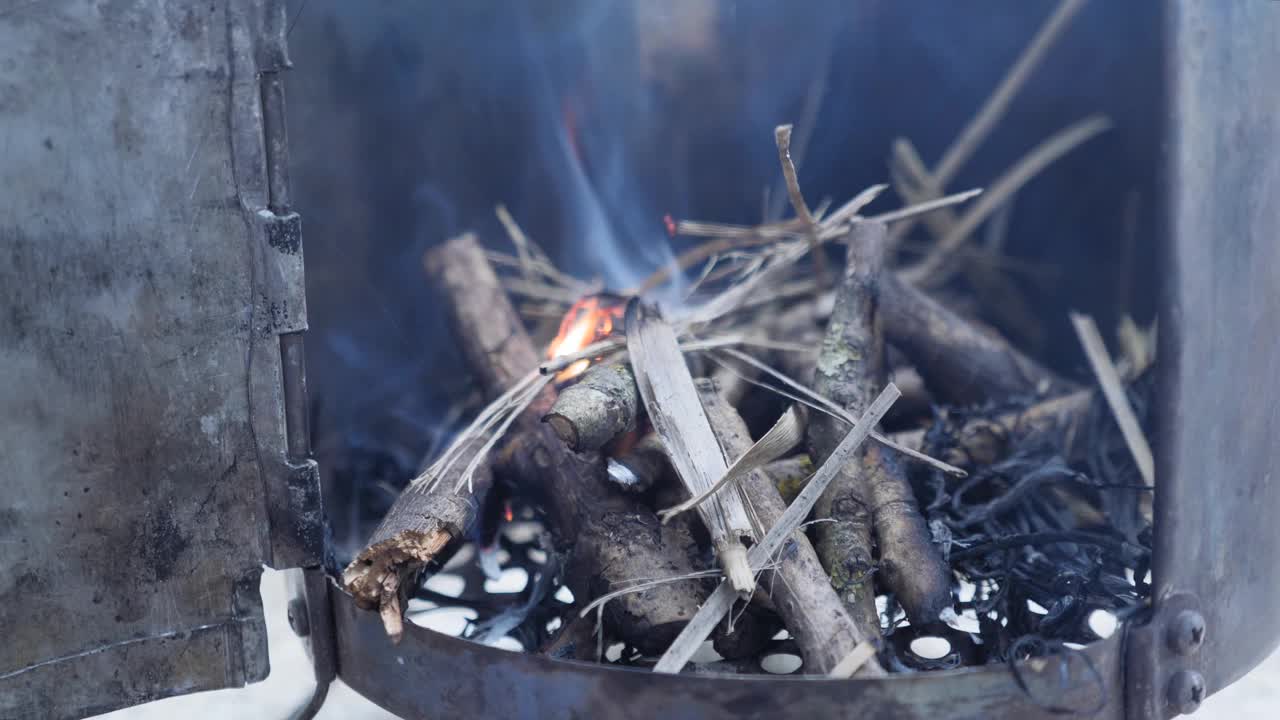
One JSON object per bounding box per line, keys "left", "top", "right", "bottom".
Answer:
{"left": 1125, "top": 592, "right": 1207, "bottom": 720}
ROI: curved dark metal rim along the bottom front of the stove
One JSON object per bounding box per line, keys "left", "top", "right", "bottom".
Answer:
{"left": 330, "top": 579, "right": 1124, "bottom": 720}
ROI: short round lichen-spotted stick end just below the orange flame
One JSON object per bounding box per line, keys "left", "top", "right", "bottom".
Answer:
{"left": 543, "top": 363, "right": 640, "bottom": 452}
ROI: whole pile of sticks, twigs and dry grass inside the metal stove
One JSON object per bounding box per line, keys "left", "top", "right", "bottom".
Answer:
{"left": 346, "top": 0, "right": 1151, "bottom": 676}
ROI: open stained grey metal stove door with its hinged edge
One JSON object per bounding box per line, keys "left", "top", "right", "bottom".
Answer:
{"left": 0, "top": 0, "right": 323, "bottom": 717}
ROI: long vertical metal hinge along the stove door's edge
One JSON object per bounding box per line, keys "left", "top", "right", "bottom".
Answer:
{"left": 232, "top": 0, "right": 325, "bottom": 569}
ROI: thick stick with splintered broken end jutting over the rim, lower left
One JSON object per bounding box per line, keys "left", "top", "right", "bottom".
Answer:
{"left": 342, "top": 438, "right": 493, "bottom": 642}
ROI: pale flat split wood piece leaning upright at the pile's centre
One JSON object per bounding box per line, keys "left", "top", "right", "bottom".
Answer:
{"left": 626, "top": 300, "right": 756, "bottom": 597}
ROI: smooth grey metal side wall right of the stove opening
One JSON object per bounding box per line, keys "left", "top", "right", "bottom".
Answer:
{"left": 1152, "top": 0, "right": 1280, "bottom": 716}
